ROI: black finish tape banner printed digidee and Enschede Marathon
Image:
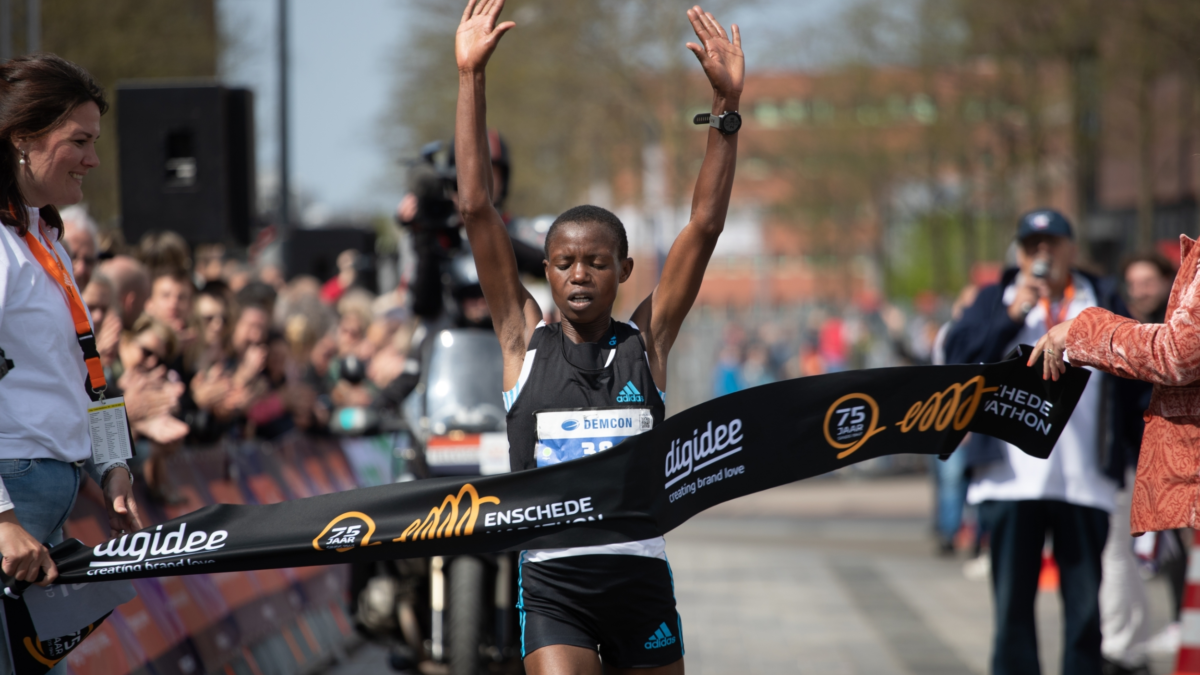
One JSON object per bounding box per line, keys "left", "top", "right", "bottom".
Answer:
{"left": 54, "top": 347, "right": 1090, "bottom": 584}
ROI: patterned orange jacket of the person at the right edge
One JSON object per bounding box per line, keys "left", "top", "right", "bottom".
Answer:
{"left": 1067, "top": 237, "right": 1200, "bottom": 534}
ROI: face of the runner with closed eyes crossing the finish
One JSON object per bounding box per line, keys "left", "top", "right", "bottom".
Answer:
{"left": 546, "top": 222, "right": 634, "bottom": 324}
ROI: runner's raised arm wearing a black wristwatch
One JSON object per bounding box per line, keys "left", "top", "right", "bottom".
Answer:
{"left": 632, "top": 6, "right": 745, "bottom": 387}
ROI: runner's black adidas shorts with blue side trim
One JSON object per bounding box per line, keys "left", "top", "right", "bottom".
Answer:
{"left": 517, "top": 555, "right": 683, "bottom": 668}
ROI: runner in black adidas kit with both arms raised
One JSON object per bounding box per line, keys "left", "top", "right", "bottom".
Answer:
{"left": 455, "top": 0, "right": 745, "bottom": 675}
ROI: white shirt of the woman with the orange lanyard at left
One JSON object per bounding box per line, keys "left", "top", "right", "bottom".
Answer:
{"left": 0, "top": 209, "right": 91, "bottom": 512}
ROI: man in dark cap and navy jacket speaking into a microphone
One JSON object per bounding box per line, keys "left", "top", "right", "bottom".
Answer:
{"left": 946, "top": 209, "right": 1145, "bottom": 675}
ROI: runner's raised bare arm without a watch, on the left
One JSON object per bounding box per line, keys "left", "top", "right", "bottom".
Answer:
{"left": 455, "top": 0, "right": 541, "bottom": 388}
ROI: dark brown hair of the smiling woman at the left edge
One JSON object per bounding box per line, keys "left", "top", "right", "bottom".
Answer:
{"left": 0, "top": 54, "right": 108, "bottom": 237}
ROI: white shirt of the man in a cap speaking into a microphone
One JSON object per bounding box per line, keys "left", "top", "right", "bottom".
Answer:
{"left": 967, "top": 274, "right": 1116, "bottom": 512}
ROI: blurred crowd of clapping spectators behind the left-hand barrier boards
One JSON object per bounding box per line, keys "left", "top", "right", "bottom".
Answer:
{"left": 62, "top": 208, "right": 412, "bottom": 502}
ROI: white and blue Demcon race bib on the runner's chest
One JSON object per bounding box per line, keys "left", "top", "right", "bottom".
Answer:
{"left": 534, "top": 408, "right": 654, "bottom": 467}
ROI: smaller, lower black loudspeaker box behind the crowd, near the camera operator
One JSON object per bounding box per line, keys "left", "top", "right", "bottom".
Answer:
{"left": 283, "top": 226, "right": 379, "bottom": 293}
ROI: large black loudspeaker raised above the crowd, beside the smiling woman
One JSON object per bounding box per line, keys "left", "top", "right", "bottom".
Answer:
{"left": 116, "top": 82, "right": 256, "bottom": 245}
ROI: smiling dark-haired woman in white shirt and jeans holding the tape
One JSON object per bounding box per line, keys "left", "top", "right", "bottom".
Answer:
{"left": 0, "top": 54, "right": 142, "bottom": 610}
